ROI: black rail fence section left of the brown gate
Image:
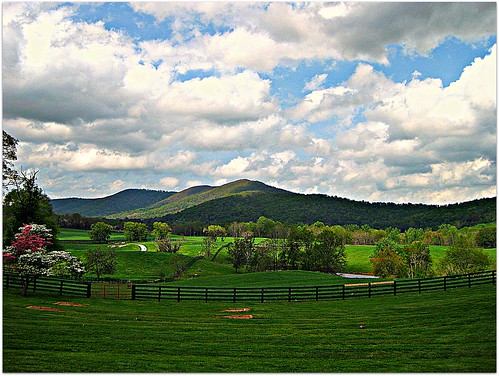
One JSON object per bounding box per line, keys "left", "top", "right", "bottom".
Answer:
{"left": 3, "top": 274, "right": 92, "bottom": 298}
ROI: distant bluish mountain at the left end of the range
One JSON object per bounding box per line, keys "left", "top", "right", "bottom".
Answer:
{"left": 50, "top": 189, "right": 176, "bottom": 217}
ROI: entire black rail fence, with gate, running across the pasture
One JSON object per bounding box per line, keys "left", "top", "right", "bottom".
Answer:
{"left": 3, "top": 270, "right": 496, "bottom": 303}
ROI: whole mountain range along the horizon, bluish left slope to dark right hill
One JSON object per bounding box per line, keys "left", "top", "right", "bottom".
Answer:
{"left": 53, "top": 180, "right": 496, "bottom": 229}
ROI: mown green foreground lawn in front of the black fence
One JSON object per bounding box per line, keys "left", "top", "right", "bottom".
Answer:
{"left": 3, "top": 285, "right": 496, "bottom": 373}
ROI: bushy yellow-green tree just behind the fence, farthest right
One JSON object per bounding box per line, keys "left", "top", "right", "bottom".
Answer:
{"left": 437, "top": 235, "right": 493, "bottom": 275}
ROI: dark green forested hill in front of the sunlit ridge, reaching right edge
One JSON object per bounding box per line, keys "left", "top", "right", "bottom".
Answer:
{"left": 151, "top": 188, "right": 496, "bottom": 230}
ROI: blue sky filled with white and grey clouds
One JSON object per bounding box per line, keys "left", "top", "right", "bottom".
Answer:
{"left": 2, "top": 1, "right": 497, "bottom": 204}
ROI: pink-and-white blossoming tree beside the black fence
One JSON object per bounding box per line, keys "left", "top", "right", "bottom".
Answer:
{"left": 3, "top": 224, "right": 85, "bottom": 296}
